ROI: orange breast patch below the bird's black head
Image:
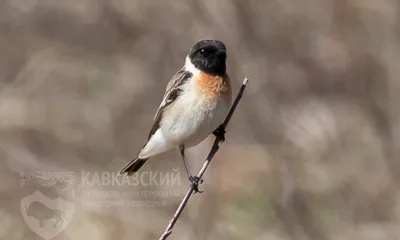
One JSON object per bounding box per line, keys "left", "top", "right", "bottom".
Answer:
{"left": 193, "top": 72, "right": 232, "bottom": 102}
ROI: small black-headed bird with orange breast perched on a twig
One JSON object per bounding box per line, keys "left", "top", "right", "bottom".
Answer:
{"left": 119, "top": 40, "right": 232, "bottom": 192}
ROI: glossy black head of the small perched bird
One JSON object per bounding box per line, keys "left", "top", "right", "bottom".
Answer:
{"left": 189, "top": 40, "right": 226, "bottom": 76}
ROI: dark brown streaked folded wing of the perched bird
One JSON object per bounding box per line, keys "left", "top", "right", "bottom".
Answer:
{"left": 148, "top": 68, "right": 192, "bottom": 139}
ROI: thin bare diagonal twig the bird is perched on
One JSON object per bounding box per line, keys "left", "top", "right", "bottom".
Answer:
{"left": 159, "top": 77, "right": 249, "bottom": 240}
